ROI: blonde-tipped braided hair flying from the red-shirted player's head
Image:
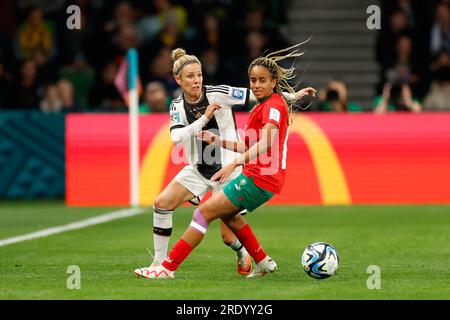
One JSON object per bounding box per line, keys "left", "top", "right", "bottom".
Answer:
{"left": 248, "top": 38, "right": 311, "bottom": 124}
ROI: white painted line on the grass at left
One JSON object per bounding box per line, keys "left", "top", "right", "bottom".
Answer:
{"left": 0, "top": 208, "right": 145, "bottom": 247}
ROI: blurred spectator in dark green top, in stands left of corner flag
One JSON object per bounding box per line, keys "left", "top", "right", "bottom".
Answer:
{"left": 59, "top": 54, "right": 95, "bottom": 110}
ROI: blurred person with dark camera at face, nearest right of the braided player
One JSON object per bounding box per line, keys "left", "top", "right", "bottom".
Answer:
{"left": 319, "top": 80, "right": 363, "bottom": 112}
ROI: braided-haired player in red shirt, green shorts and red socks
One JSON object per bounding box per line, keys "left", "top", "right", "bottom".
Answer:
{"left": 140, "top": 45, "right": 316, "bottom": 279}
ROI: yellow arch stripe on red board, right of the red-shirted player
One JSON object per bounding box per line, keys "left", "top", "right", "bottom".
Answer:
{"left": 288, "top": 115, "right": 351, "bottom": 205}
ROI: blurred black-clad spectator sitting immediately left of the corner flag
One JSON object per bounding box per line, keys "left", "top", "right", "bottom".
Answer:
{"left": 90, "top": 62, "right": 127, "bottom": 111}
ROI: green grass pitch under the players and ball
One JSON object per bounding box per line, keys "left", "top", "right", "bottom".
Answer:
{"left": 0, "top": 202, "right": 450, "bottom": 300}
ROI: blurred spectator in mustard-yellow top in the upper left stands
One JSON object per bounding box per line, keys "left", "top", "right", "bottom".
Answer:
{"left": 15, "top": 7, "right": 56, "bottom": 63}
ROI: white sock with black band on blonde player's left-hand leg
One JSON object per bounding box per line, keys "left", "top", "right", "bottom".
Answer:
{"left": 153, "top": 207, "right": 173, "bottom": 264}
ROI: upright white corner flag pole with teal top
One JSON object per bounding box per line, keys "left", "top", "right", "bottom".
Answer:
{"left": 127, "top": 48, "right": 139, "bottom": 207}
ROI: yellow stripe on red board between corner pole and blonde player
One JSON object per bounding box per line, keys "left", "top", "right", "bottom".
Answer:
{"left": 139, "top": 124, "right": 173, "bottom": 206}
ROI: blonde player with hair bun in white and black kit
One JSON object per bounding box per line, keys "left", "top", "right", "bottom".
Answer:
{"left": 135, "top": 49, "right": 310, "bottom": 276}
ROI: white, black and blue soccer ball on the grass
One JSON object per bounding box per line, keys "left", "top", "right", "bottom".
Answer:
{"left": 302, "top": 242, "right": 339, "bottom": 279}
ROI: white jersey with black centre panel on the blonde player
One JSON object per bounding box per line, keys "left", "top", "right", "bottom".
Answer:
{"left": 170, "top": 85, "right": 250, "bottom": 179}
